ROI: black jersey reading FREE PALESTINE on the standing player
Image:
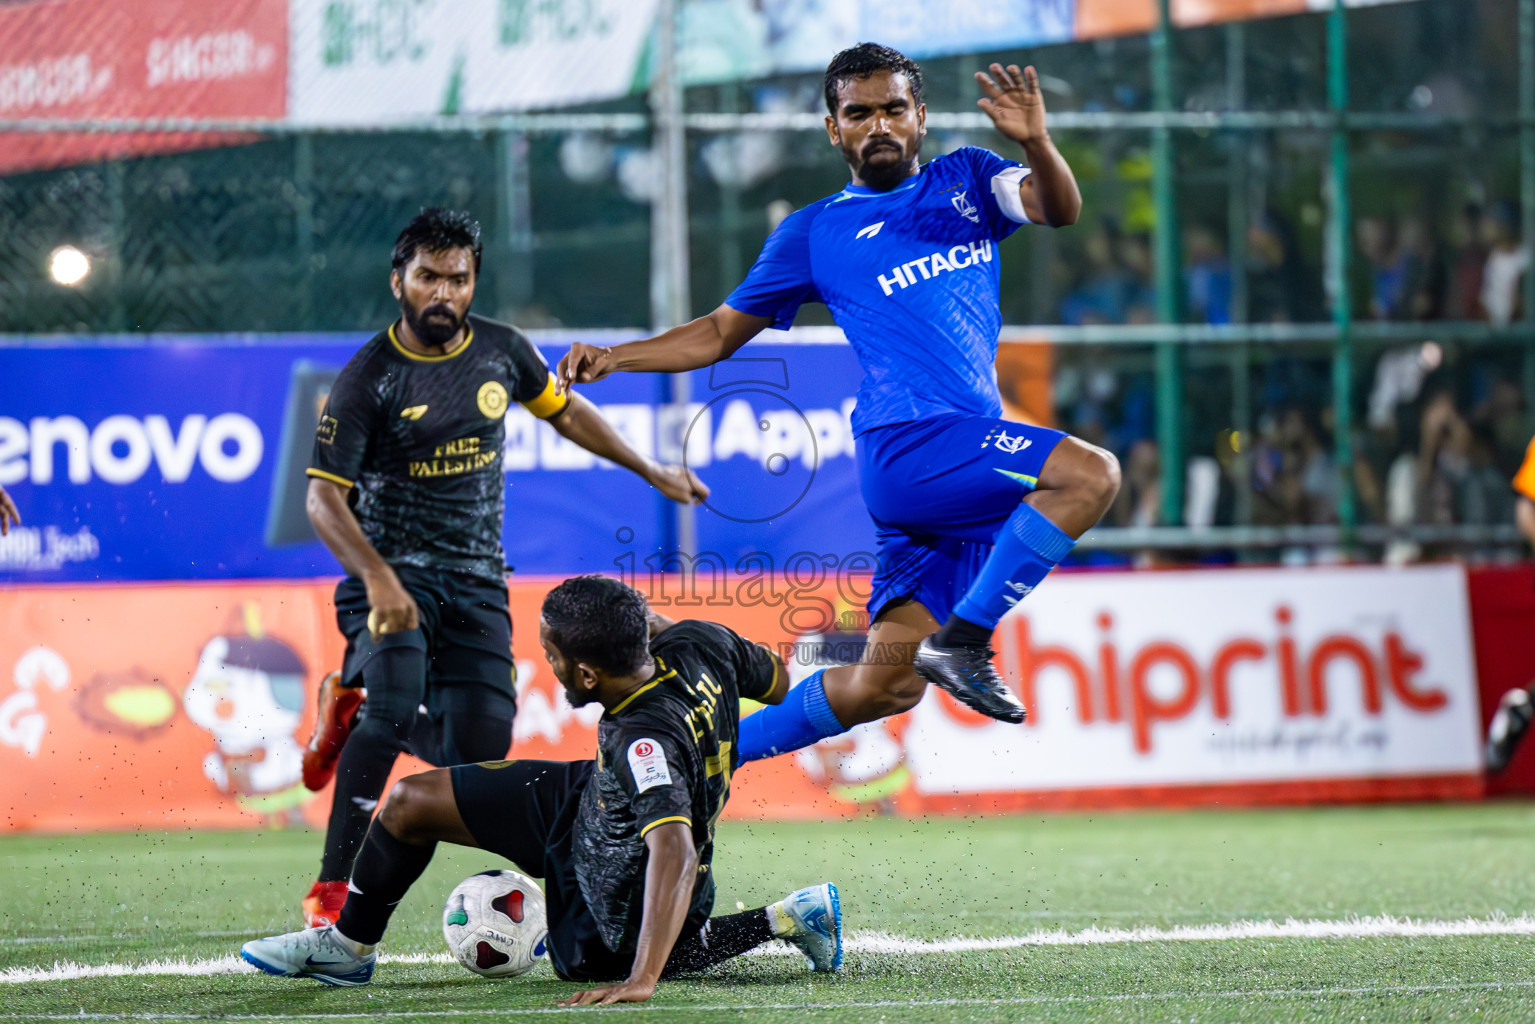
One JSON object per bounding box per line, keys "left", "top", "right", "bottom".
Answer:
{"left": 309, "top": 316, "right": 569, "bottom": 580}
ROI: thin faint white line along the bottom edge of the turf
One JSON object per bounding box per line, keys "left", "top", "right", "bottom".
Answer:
{"left": 9, "top": 981, "right": 1535, "bottom": 1021}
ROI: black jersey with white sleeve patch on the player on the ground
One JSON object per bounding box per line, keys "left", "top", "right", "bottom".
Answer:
{"left": 573, "top": 622, "right": 778, "bottom": 952}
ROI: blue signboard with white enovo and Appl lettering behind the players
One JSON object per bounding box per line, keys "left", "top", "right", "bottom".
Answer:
{"left": 0, "top": 335, "right": 873, "bottom": 582}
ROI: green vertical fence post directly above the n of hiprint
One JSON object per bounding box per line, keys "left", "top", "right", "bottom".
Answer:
{"left": 1328, "top": 0, "right": 1358, "bottom": 547}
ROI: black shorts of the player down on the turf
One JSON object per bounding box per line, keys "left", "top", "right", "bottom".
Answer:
{"left": 448, "top": 760, "right": 634, "bottom": 981}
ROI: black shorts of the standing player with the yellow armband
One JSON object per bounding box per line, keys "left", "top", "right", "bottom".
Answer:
{"left": 336, "top": 565, "right": 516, "bottom": 718}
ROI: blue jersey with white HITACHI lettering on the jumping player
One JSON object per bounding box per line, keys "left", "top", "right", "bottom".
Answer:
{"left": 725, "top": 146, "right": 1028, "bottom": 434}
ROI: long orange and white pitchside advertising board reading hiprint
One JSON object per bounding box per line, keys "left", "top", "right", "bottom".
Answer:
{"left": 0, "top": 562, "right": 1483, "bottom": 832}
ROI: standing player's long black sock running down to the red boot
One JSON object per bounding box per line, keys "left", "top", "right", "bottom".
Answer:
{"left": 319, "top": 648, "right": 427, "bottom": 881}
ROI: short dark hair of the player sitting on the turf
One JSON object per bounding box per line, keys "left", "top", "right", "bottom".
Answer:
{"left": 542, "top": 576, "right": 651, "bottom": 676}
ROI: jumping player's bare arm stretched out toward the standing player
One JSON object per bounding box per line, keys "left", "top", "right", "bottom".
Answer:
{"left": 554, "top": 306, "right": 772, "bottom": 390}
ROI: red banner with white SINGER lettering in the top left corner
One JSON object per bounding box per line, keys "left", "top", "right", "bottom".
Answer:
{"left": 0, "top": 0, "right": 287, "bottom": 173}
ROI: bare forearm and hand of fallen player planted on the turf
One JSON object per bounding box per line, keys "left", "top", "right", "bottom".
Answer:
{"left": 565, "top": 821, "right": 698, "bottom": 1006}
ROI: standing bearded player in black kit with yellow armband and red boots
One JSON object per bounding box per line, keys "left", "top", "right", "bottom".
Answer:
{"left": 304, "top": 209, "right": 709, "bottom": 927}
